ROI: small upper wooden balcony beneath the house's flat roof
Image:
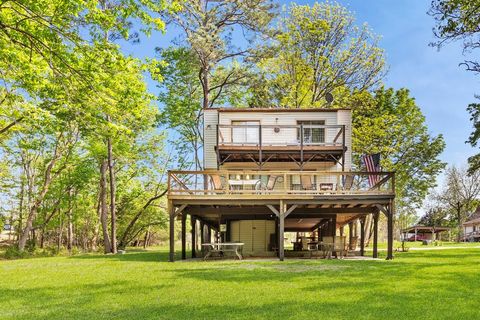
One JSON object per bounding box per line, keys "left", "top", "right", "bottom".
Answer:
{"left": 215, "top": 121, "right": 347, "bottom": 168}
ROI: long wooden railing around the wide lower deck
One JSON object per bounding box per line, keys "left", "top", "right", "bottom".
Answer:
{"left": 168, "top": 170, "right": 395, "bottom": 196}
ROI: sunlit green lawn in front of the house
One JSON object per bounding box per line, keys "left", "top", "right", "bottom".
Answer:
{"left": 0, "top": 248, "right": 480, "bottom": 319}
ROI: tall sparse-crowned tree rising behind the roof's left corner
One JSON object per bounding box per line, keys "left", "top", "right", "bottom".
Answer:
{"left": 159, "top": 0, "right": 276, "bottom": 109}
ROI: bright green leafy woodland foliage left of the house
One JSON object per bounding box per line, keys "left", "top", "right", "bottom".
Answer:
{"left": 0, "top": 0, "right": 174, "bottom": 254}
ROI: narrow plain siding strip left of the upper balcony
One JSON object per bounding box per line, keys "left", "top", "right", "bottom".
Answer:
{"left": 203, "top": 109, "right": 218, "bottom": 169}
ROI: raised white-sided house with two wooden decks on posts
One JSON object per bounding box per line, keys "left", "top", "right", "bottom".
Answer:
{"left": 168, "top": 108, "right": 395, "bottom": 261}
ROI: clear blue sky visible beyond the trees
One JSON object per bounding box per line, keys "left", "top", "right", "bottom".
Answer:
{"left": 124, "top": 0, "right": 480, "bottom": 180}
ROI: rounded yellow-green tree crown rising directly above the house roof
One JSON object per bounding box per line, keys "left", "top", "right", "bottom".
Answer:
{"left": 249, "top": 2, "right": 385, "bottom": 108}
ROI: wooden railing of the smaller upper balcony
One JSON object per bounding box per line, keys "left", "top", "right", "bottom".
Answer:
{"left": 217, "top": 124, "right": 345, "bottom": 147}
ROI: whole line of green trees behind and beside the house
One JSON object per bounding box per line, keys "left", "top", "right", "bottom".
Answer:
{"left": 0, "top": 0, "right": 476, "bottom": 253}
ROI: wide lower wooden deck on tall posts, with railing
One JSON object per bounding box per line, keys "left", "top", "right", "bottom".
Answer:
{"left": 168, "top": 170, "right": 395, "bottom": 260}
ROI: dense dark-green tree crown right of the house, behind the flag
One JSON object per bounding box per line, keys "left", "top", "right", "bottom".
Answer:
{"left": 352, "top": 88, "right": 445, "bottom": 214}
